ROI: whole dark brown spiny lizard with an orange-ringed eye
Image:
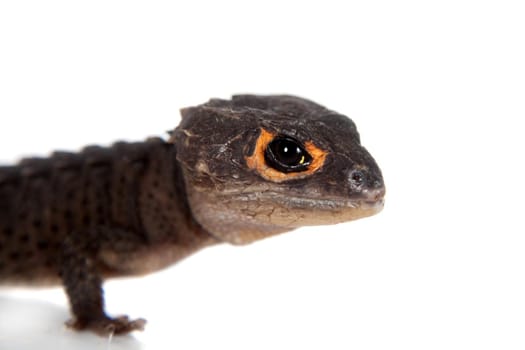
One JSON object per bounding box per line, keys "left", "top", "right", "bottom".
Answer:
{"left": 0, "top": 95, "right": 385, "bottom": 335}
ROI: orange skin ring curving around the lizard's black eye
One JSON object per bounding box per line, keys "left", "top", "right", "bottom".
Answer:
{"left": 246, "top": 128, "right": 327, "bottom": 182}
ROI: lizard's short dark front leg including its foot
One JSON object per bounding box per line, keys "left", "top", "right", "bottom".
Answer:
{"left": 60, "top": 232, "right": 146, "bottom": 336}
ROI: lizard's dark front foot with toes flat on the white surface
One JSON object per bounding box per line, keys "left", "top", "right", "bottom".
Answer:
{"left": 66, "top": 316, "right": 146, "bottom": 336}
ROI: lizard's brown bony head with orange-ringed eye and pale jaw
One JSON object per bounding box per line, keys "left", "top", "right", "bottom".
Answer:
{"left": 171, "top": 95, "right": 385, "bottom": 244}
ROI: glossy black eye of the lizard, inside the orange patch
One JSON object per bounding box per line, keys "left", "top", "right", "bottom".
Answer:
{"left": 264, "top": 136, "right": 312, "bottom": 173}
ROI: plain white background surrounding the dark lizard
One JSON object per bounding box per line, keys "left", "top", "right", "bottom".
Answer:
{"left": 0, "top": 0, "right": 525, "bottom": 349}
